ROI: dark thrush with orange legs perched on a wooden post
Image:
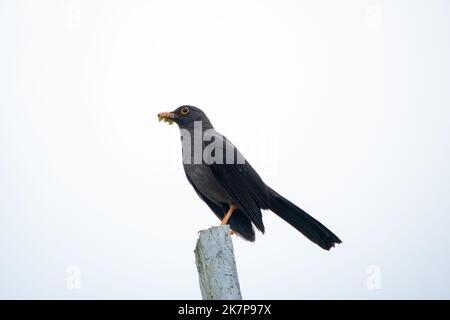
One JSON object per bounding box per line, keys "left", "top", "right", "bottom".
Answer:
{"left": 158, "top": 105, "right": 342, "bottom": 250}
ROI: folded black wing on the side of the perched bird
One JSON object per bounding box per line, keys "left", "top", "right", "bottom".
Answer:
{"left": 209, "top": 137, "right": 269, "bottom": 232}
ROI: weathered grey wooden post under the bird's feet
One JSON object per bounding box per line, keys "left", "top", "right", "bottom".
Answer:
{"left": 194, "top": 225, "right": 242, "bottom": 300}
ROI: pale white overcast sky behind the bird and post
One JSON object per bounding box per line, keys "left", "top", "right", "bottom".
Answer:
{"left": 0, "top": 0, "right": 450, "bottom": 299}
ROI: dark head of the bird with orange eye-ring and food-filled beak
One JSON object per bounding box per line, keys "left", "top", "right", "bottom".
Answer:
{"left": 158, "top": 105, "right": 211, "bottom": 128}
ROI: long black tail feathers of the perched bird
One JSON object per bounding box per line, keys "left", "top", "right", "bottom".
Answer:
{"left": 269, "top": 188, "right": 342, "bottom": 250}
